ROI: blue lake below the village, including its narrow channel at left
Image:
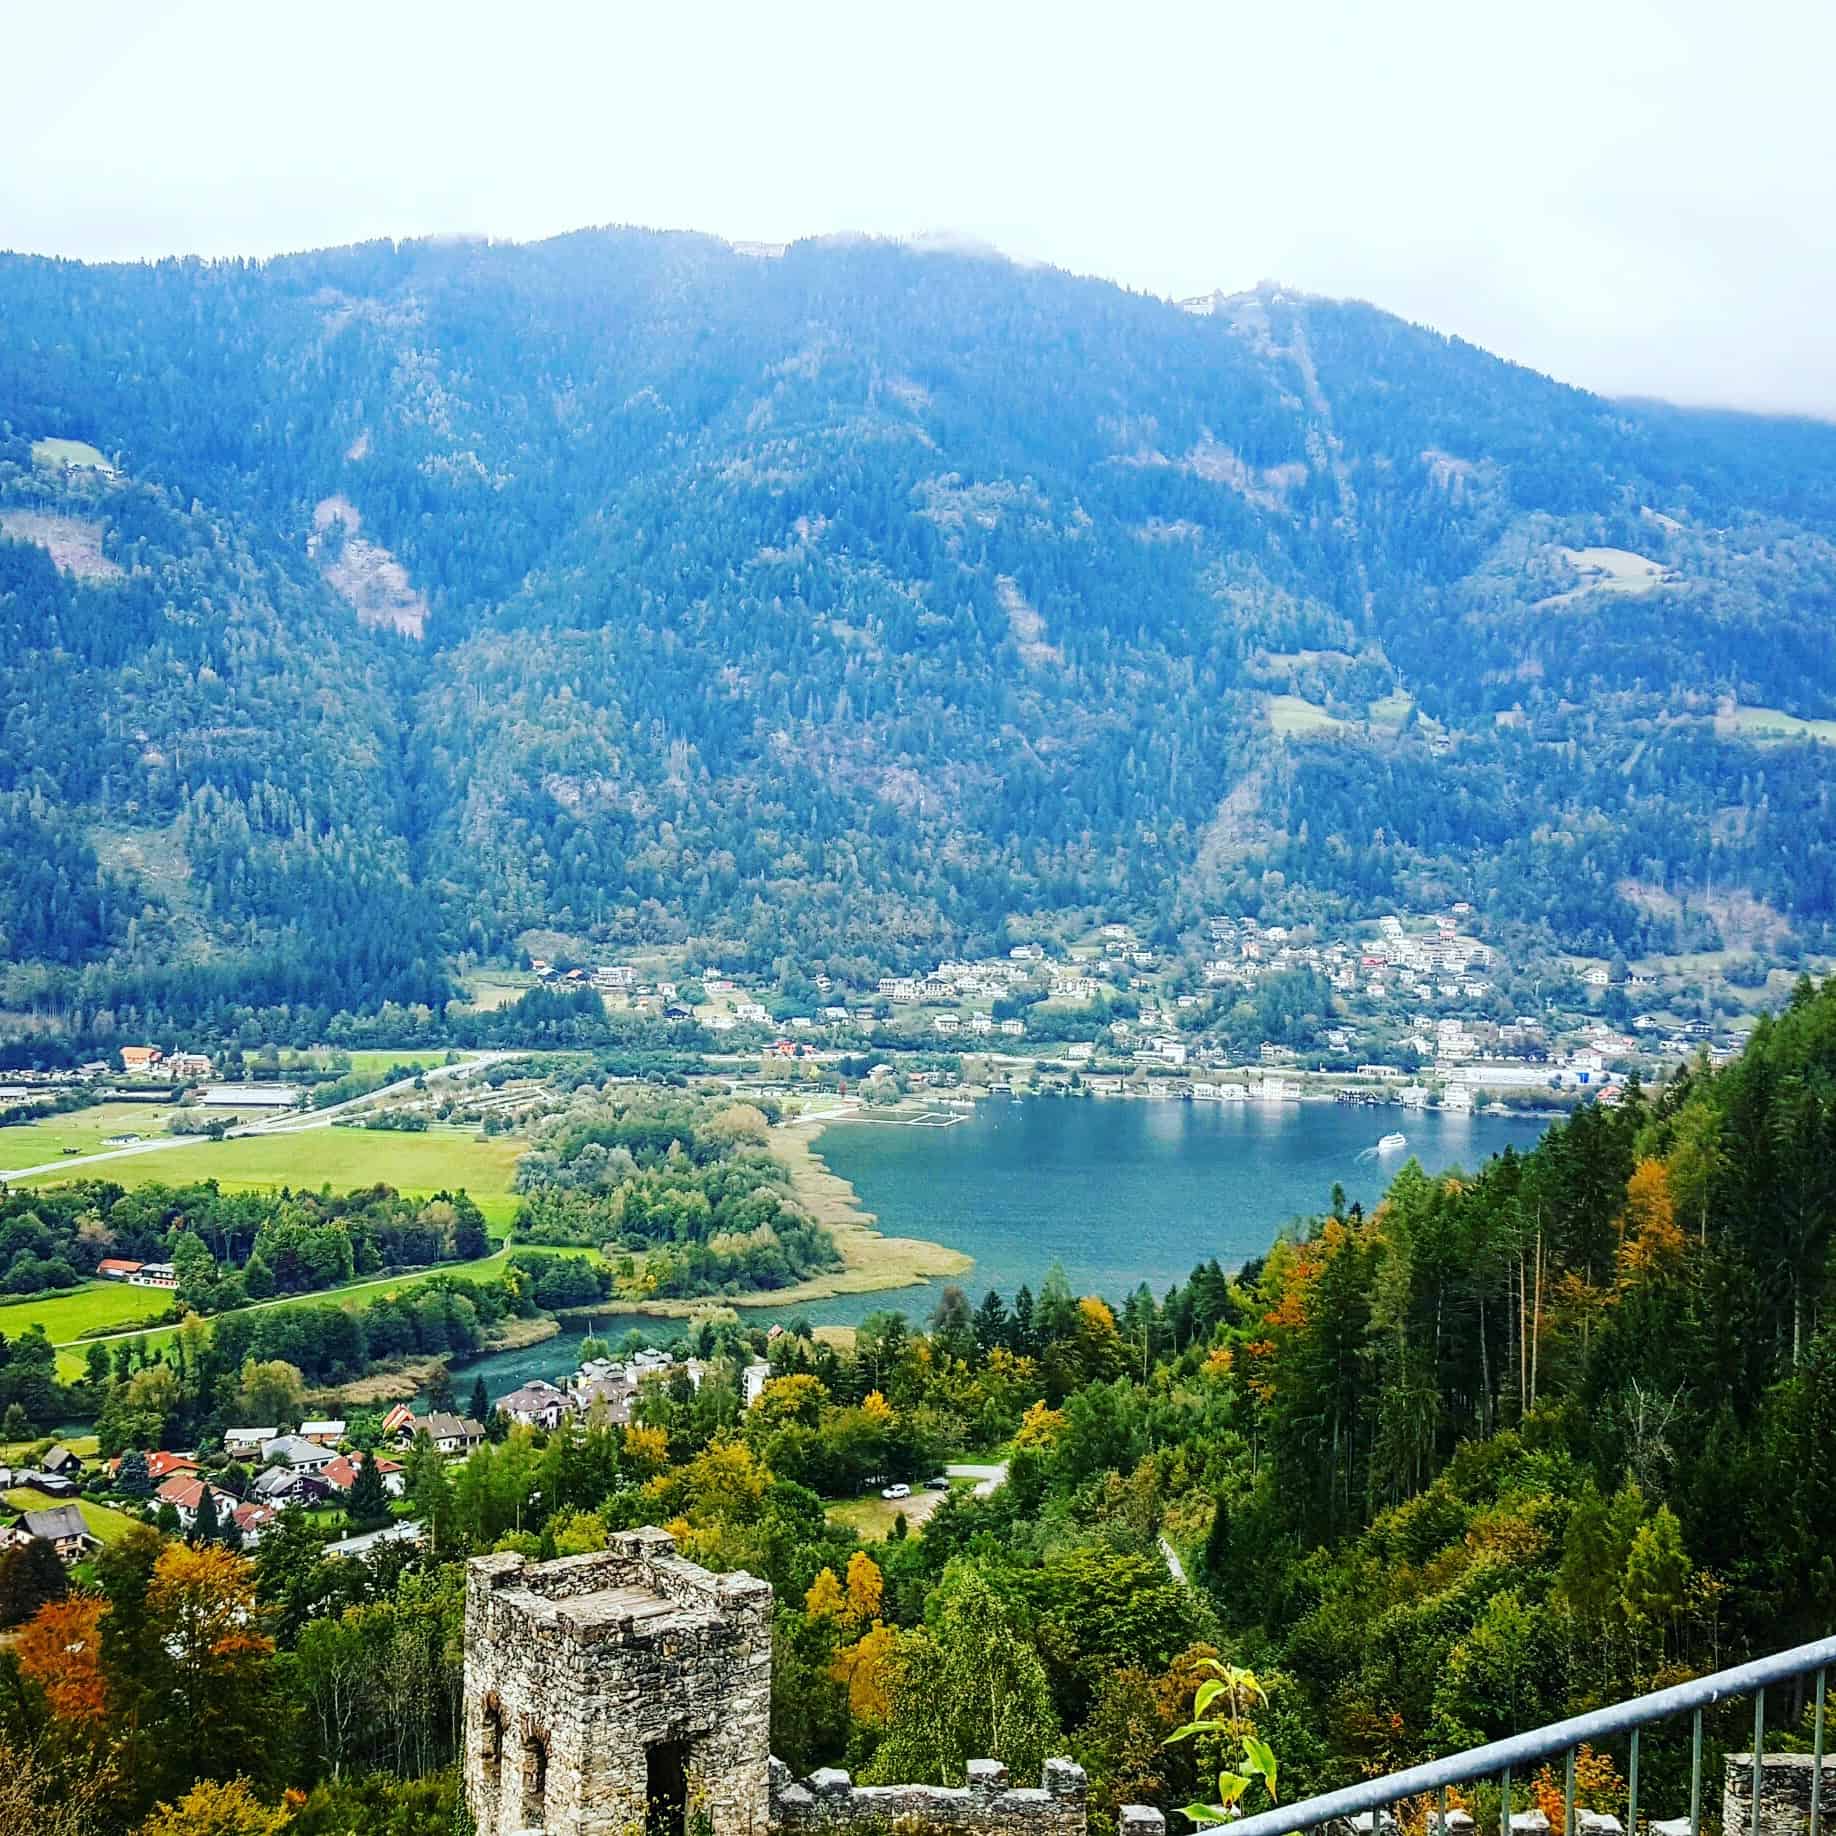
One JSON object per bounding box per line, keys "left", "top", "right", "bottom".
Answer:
{"left": 444, "top": 1098, "right": 1548, "bottom": 1395}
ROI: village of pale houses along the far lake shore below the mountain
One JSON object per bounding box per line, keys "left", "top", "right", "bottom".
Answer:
{"left": 529, "top": 901, "right": 1766, "bottom": 1111}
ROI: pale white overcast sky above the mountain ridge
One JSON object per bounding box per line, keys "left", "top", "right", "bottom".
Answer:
{"left": 14, "top": 0, "right": 1836, "bottom": 415}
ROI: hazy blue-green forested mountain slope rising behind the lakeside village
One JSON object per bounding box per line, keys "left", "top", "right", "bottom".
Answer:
{"left": 0, "top": 231, "right": 1836, "bottom": 1015}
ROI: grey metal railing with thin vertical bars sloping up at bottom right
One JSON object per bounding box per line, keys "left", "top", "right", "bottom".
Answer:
{"left": 1228, "top": 1638, "right": 1836, "bottom": 1836}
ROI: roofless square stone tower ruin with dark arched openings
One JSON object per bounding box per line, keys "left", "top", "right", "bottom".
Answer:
{"left": 465, "top": 1529, "right": 771, "bottom": 1836}
